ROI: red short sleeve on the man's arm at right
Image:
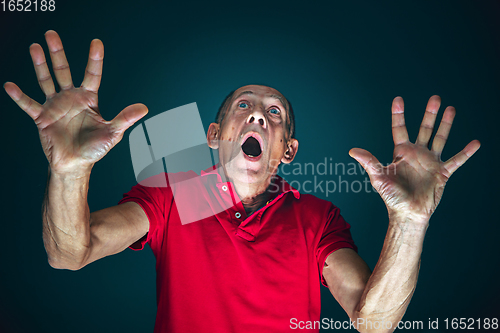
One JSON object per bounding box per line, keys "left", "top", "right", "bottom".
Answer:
{"left": 316, "top": 204, "right": 358, "bottom": 287}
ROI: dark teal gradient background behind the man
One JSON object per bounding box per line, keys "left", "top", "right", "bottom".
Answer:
{"left": 0, "top": 0, "right": 500, "bottom": 333}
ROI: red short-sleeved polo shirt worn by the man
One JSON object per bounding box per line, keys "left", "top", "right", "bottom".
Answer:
{"left": 120, "top": 168, "right": 356, "bottom": 333}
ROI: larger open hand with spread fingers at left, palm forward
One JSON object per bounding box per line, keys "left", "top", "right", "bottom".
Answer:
{"left": 4, "top": 30, "right": 147, "bottom": 173}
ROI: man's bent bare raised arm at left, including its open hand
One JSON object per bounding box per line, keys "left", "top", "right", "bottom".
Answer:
{"left": 4, "top": 30, "right": 149, "bottom": 270}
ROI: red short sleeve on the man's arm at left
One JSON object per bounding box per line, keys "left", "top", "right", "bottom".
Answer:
{"left": 118, "top": 174, "right": 172, "bottom": 251}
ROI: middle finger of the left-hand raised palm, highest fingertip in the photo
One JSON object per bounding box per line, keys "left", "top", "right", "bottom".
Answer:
{"left": 45, "top": 30, "right": 73, "bottom": 90}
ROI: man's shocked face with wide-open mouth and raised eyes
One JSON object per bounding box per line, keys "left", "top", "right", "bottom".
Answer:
{"left": 208, "top": 85, "right": 290, "bottom": 184}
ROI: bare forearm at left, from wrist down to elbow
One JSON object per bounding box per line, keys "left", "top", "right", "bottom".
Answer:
{"left": 43, "top": 170, "right": 90, "bottom": 270}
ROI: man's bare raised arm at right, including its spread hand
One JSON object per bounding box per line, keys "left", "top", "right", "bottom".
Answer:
{"left": 323, "top": 96, "right": 480, "bottom": 332}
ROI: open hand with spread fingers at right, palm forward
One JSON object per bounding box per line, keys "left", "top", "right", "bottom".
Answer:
{"left": 349, "top": 96, "right": 480, "bottom": 223}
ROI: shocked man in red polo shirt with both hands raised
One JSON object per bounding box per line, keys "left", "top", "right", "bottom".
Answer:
{"left": 4, "top": 31, "right": 480, "bottom": 332}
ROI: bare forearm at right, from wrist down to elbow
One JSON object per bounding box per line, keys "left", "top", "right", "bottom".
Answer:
{"left": 353, "top": 215, "right": 428, "bottom": 332}
